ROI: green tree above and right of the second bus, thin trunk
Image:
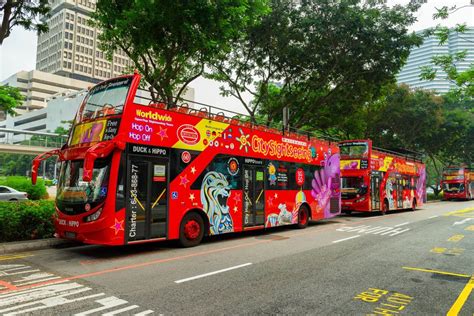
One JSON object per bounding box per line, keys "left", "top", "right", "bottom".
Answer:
{"left": 338, "top": 85, "right": 474, "bottom": 196}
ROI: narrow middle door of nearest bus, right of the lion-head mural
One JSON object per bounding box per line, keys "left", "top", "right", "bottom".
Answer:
{"left": 242, "top": 159, "right": 265, "bottom": 227}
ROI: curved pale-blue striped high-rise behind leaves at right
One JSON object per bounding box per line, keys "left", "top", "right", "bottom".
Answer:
{"left": 397, "top": 27, "right": 474, "bottom": 94}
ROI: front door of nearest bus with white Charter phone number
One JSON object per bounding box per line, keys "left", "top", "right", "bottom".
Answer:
{"left": 126, "top": 151, "right": 169, "bottom": 242}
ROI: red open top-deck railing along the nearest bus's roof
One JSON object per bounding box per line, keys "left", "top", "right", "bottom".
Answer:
{"left": 134, "top": 89, "right": 339, "bottom": 143}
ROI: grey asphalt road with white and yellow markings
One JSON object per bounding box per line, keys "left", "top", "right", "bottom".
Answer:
{"left": 0, "top": 201, "right": 474, "bottom": 315}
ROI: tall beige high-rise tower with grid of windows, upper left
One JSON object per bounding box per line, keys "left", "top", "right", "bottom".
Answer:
{"left": 36, "top": 0, "right": 131, "bottom": 83}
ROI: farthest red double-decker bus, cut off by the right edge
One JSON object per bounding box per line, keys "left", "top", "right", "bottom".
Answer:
{"left": 441, "top": 166, "right": 474, "bottom": 200}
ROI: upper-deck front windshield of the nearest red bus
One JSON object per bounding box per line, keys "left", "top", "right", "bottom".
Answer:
{"left": 78, "top": 77, "right": 132, "bottom": 123}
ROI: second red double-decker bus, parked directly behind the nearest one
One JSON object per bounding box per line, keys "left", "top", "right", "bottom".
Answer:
{"left": 339, "top": 140, "right": 426, "bottom": 214}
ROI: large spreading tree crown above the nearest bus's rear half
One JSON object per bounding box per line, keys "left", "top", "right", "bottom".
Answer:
{"left": 209, "top": 0, "right": 421, "bottom": 124}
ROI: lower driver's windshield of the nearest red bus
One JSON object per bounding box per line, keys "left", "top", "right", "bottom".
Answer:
{"left": 56, "top": 159, "right": 110, "bottom": 215}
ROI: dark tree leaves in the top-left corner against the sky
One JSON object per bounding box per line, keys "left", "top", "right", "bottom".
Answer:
{"left": 0, "top": 0, "right": 50, "bottom": 45}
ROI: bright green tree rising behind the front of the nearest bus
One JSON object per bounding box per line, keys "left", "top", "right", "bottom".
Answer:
{"left": 93, "top": 0, "right": 267, "bottom": 104}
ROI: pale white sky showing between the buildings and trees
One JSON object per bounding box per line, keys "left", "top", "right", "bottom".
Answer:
{"left": 0, "top": 0, "right": 474, "bottom": 112}
